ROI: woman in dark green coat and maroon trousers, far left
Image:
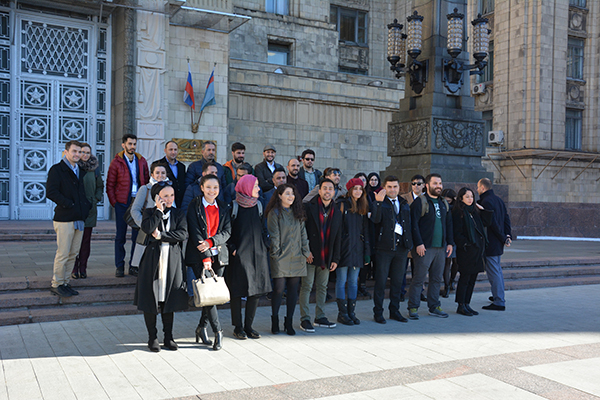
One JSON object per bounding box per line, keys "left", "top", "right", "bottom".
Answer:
{"left": 71, "top": 143, "right": 104, "bottom": 279}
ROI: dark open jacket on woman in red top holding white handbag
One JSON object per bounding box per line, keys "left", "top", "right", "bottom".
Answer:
{"left": 185, "top": 196, "right": 231, "bottom": 276}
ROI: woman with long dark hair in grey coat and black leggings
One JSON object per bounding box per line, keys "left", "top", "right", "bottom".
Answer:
{"left": 265, "top": 184, "right": 312, "bottom": 335}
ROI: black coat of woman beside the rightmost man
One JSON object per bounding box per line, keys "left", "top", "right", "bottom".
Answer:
{"left": 452, "top": 207, "right": 494, "bottom": 274}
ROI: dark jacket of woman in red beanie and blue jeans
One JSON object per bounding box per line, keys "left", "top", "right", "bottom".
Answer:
{"left": 338, "top": 198, "right": 371, "bottom": 268}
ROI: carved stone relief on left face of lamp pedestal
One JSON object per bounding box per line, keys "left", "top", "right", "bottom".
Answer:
{"left": 388, "top": 120, "right": 429, "bottom": 156}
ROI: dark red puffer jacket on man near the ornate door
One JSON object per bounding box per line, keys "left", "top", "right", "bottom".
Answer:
{"left": 106, "top": 150, "right": 150, "bottom": 207}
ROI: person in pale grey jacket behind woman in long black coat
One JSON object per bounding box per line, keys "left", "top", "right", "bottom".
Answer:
{"left": 130, "top": 161, "right": 167, "bottom": 272}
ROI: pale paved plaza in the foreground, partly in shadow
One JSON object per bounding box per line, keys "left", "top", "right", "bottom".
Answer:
{"left": 0, "top": 285, "right": 600, "bottom": 400}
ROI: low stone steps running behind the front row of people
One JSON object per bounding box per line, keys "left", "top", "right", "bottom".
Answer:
{"left": 0, "top": 258, "right": 600, "bottom": 326}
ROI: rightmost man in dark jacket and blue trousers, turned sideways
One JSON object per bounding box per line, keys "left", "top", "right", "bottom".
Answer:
{"left": 477, "top": 178, "right": 512, "bottom": 311}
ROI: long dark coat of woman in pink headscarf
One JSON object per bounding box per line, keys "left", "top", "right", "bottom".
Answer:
{"left": 225, "top": 206, "right": 272, "bottom": 297}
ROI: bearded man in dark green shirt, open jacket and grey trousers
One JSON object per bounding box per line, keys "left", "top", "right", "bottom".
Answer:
{"left": 408, "top": 174, "right": 454, "bottom": 319}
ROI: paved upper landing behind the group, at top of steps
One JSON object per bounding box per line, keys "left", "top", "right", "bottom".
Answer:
{"left": 0, "top": 240, "right": 600, "bottom": 278}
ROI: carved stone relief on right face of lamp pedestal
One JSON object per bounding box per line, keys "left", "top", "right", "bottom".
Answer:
{"left": 433, "top": 118, "right": 483, "bottom": 153}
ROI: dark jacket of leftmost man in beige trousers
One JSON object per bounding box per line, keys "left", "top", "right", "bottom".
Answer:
{"left": 46, "top": 160, "right": 93, "bottom": 222}
